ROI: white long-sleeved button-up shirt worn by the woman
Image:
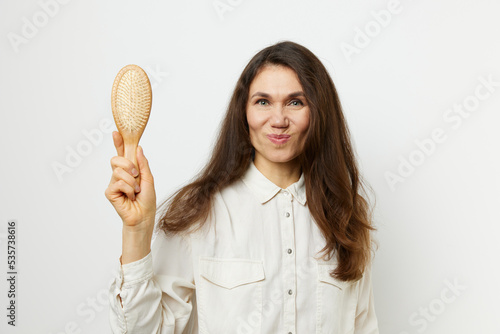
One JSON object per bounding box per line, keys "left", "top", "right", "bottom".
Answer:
{"left": 110, "top": 162, "right": 378, "bottom": 334}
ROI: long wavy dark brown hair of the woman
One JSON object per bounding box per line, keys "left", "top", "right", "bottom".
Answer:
{"left": 158, "top": 41, "right": 375, "bottom": 281}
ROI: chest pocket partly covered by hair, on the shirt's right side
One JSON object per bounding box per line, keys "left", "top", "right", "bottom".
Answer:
{"left": 316, "top": 261, "right": 358, "bottom": 334}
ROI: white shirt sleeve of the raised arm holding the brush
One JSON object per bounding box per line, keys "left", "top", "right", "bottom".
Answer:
{"left": 109, "top": 232, "right": 195, "bottom": 334}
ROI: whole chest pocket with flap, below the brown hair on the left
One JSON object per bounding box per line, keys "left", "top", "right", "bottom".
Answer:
{"left": 196, "top": 257, "right": 265, "bottom": 334}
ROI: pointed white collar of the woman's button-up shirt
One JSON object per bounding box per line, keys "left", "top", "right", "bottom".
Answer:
{"left": 242, "top": 160, "right": 307, "bottom": 205}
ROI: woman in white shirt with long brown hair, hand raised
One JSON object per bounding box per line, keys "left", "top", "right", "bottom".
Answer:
{"left": 106, "top": 41, "right": 378, "bottom": 334}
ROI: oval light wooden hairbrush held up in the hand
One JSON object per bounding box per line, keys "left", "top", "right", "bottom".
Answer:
{"left": 111, "top": 65, "right": 152, "bottom": 184}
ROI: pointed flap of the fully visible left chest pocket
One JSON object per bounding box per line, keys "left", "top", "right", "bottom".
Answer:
{"left": 199, "top": 257, "right": 265, "bottom": 289}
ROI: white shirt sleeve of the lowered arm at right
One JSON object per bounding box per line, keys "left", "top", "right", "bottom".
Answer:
{"left": 354, "top": 264, "right": 379, "bottom": 334}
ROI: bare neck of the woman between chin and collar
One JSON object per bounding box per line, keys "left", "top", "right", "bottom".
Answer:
{"left": 253, "top": 155, "right": 301, "bottom": 189}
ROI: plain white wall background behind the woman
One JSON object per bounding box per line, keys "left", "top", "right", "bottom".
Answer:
{"left": 0, "top": 0, "right": 500, "bottom": 334}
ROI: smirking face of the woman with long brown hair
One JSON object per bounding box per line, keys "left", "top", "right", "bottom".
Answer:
{"left": 246, "top": 65, "right": 309, "bottom": 168}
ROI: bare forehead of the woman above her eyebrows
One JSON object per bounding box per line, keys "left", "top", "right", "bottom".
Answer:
{"left": 249, "top": 65, "right": 302, "bottom": 94}
